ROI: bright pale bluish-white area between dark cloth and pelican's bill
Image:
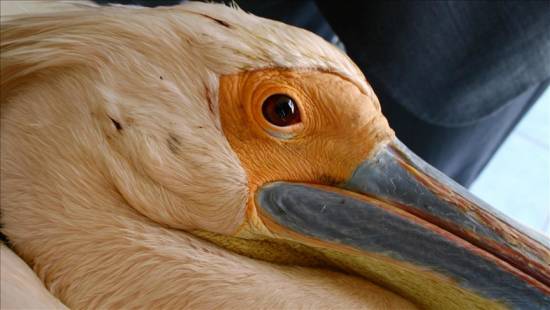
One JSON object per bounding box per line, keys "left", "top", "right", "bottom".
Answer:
{"left": 470, "top": 89, "right": 550, "bottom": 236}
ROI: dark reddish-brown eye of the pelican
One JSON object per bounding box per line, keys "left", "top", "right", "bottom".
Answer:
{"left": 262, "top": 94, "right": 302, "bottom": 127}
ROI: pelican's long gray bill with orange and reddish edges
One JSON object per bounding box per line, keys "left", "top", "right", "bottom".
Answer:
{"left": 255, "top": 140, "right": 550, "bottom": 309}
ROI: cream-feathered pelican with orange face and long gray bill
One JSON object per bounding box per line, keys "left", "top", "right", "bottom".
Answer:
{"left": 0, "top": 2, "right": 550, "bottom": 309}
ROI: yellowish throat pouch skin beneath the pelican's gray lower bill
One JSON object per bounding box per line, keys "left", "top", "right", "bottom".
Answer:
{"left": 194, "top": 220, "right": 546, "bottom": 309}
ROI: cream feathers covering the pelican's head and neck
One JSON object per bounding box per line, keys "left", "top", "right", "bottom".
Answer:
{"left": 1, "top": 3, "right": 414, "bottom": 308}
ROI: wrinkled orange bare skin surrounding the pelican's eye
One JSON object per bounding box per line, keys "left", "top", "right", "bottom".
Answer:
{"left": 220, "top": 69, "right": 394, "bottom": 204}
